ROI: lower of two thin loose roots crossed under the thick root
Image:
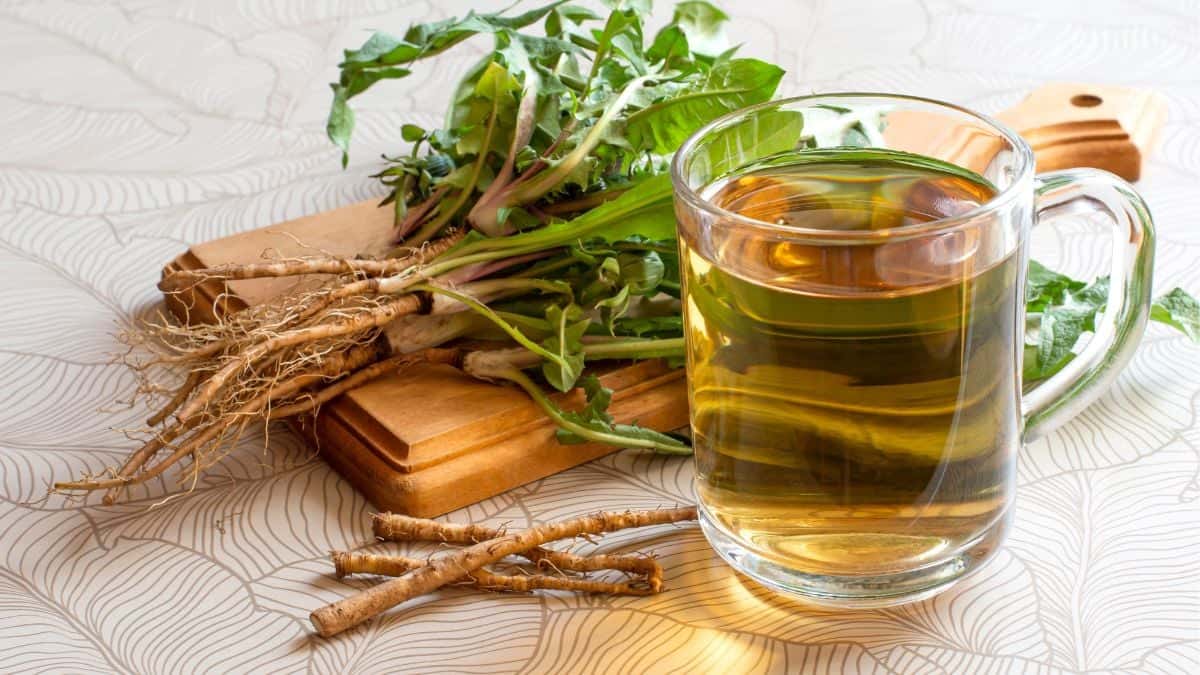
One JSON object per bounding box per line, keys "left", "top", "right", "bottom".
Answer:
{"left": 329, "top": 551, "right": 654, "bottom": 596}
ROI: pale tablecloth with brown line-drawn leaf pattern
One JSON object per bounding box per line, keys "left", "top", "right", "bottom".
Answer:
{"left": 0, "top": 0, "right": 1200, "bottom": 674}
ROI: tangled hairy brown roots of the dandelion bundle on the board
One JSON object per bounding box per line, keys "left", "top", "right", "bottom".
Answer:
{"left": 68, "top": 232, "right": 463, "bottom": 503}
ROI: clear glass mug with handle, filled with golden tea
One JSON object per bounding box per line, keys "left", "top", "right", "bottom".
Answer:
{"left": 671, "top": 94, "right": 1153, "bottom": 600}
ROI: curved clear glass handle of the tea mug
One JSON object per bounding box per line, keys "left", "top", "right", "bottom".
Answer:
{"left": 1021, "top": 169, "right": 1154, "bottom": 442}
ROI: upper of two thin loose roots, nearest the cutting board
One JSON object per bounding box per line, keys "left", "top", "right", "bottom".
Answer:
{"left": 371, "top": 513, "right": 662, "bottom": 577}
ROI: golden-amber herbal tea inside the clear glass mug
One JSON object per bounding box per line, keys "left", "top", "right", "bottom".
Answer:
{"left": 680, "top": 149, "right": 1024, "bottom": 574}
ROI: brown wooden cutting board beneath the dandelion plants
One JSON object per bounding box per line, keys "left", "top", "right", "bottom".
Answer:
{"left": 164, "top": 84, "right": 1165, "bottom": 516}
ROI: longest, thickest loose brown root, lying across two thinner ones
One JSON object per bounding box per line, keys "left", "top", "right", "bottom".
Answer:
{"left": 310, "top": 507, "right": 696, "bottom": 638}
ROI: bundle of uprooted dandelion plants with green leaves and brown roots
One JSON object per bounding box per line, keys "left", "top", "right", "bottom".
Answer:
{"left": 56, "top": 0, "right": 1200, "bottom": 503}
